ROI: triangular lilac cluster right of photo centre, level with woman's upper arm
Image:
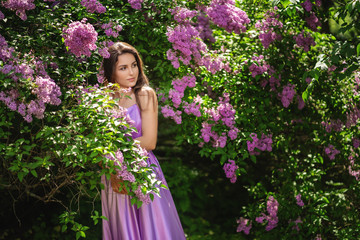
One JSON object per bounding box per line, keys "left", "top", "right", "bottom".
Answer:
{"left": 199, "top": 93, "right": 239, "bottom": 148}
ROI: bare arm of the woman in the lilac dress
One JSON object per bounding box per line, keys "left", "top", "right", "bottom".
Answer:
{"left": 136, "top": 87, "right": 158, "bottom": 151}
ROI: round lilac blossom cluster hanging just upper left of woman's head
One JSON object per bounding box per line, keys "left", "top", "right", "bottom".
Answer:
{"left": 63, "top": 18, "right": 98, "bottom": 57}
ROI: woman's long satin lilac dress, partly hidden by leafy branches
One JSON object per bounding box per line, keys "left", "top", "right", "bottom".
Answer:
{"left": 101, "top": 104, "right": 185, "bottom": 240}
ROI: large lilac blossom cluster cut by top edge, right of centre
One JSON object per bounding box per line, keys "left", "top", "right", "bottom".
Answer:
{"left": 205, "top": 0, "right": 250, "bottom": 34}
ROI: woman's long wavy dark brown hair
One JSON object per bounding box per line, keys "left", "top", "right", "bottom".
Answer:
{"left": 102, "top": 42, "right": 149, "bottom": 104}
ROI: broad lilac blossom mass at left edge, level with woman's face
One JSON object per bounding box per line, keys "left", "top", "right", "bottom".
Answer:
{"left": 0, "top": 35, "right": 61, "bottom": 122}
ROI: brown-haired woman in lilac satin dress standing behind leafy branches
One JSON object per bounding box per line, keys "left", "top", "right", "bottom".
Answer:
{"left": 101, "top": 42, "right": 185, "bottom": 240}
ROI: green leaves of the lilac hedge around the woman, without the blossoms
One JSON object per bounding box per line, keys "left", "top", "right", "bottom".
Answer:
{"left": 0, "top": 0, "right": 360, "bottom": 239}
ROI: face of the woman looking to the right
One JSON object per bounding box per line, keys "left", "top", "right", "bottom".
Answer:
{"left": 113, "top": 53, "right": 139, "bottom": 88}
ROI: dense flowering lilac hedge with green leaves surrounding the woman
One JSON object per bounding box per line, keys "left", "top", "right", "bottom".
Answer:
{"left": 0, "top": 0, "right": 360, "bottom": 239}
